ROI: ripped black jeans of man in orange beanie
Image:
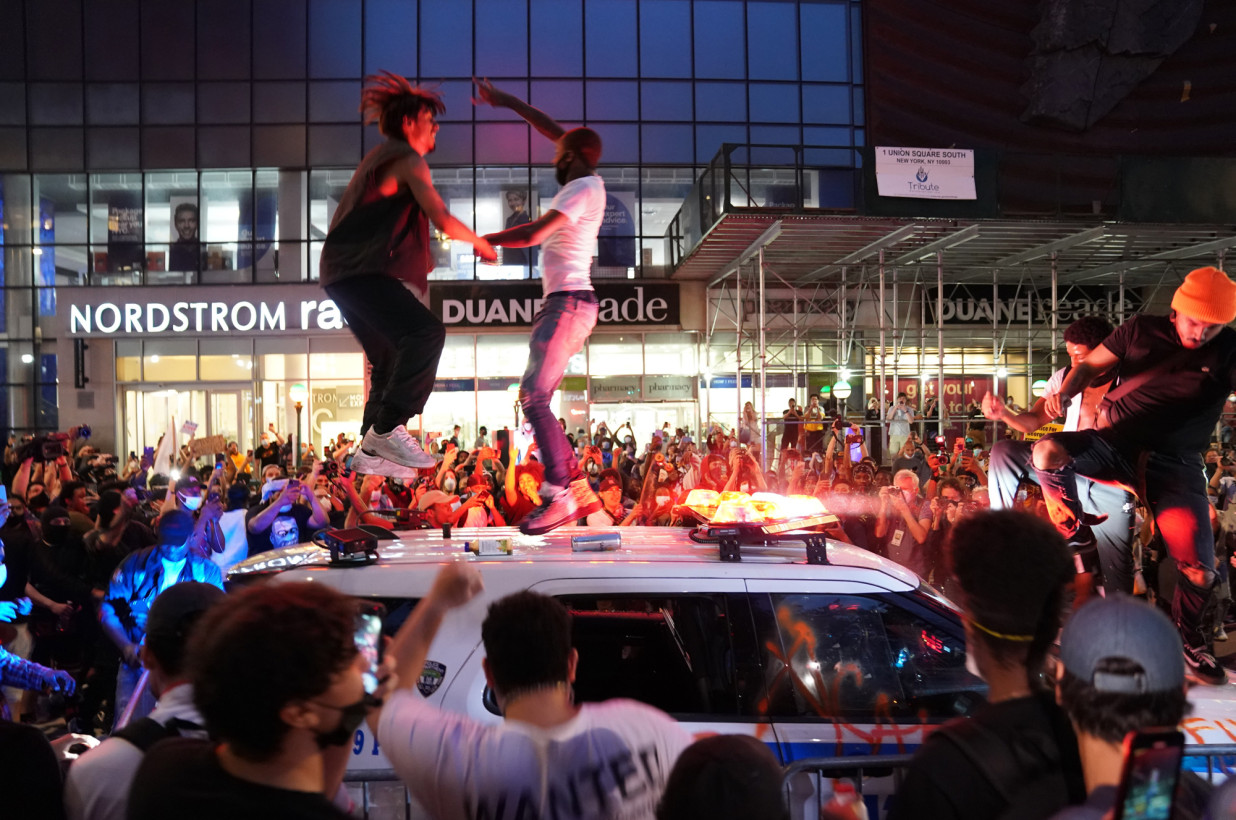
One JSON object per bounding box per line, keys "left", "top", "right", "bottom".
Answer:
{"left": 1037, "top": 430, "right": 1217, "bottom": 647}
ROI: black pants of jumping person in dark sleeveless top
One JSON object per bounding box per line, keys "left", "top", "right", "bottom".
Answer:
{"left": 326, "top": 273, "right": 446, "bottom": 437}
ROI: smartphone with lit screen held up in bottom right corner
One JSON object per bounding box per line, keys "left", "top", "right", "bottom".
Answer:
{"left": 1115, "top": 728, "right": 1184, "bottom": 820}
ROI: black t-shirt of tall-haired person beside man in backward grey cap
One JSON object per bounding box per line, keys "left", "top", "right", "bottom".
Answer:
{"left": 889, "top": 696, "right": 1085, "bottom": 820}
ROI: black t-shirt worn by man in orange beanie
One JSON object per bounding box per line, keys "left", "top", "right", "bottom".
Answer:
{"left": 1102, "top": 315, "right": 1236, "bottom": 454}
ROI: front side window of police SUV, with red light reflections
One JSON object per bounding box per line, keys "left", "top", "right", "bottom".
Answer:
{"left": 756, "top": 595, "right": 985, "bottom": 722}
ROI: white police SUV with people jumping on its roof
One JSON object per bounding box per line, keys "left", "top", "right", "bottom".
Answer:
{"left": 229, "top": 489, "right": 1236, "bottom": 816}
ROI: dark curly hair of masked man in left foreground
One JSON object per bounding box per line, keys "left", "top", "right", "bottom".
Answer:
{"left": 188, "top": 583, "right": 356, "bottom": 761}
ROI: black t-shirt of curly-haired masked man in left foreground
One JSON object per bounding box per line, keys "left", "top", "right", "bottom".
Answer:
{"left": 129, "top": 737, "right": 347, "bottom": 820}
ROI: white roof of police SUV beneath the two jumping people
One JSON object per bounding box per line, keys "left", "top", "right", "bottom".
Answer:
{"left": 229, "top": 527, "right": 921, "bottom": 596}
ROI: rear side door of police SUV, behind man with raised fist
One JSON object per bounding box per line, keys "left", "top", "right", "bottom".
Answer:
{"left": 446, "top": 578, "right": 775, "bottom": 742}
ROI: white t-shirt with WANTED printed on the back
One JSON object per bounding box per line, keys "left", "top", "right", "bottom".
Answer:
{"left": 378, "top": 690, "right": 691, "bottom": 820}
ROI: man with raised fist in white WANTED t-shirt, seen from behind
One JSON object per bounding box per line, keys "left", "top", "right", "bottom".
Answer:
{"left": 368, "top": 563, "right": 691, "bottom": 820}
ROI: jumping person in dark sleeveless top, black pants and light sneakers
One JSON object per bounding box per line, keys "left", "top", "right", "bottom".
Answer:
{"left": 320, "top": 72, "right": 497, "bottom": 477}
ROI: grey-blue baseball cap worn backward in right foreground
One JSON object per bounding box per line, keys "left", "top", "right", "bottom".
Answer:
{"left": 1060, "top": 595, "right": 1184, "bottom": 695}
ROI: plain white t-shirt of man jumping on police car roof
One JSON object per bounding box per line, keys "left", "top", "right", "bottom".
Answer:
{"left": 541, "top": 174, "right": 606, "bottom": 296}
